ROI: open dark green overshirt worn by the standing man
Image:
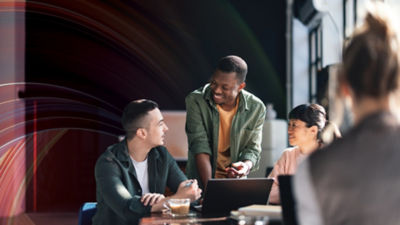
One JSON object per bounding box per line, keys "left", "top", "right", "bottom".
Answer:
{"left": 186, "top": 84, "right": 265, "bottom": 184}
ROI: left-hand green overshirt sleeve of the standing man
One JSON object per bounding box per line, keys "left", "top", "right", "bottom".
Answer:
{"left": 185, "top": 95, "right": 212, "bottom": 155}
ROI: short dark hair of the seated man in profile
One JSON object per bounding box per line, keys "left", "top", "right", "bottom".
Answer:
{"left": 121, "top": 99, "right": 158, "bottom": 140}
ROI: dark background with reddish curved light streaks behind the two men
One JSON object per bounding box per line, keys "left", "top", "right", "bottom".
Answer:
{"left": 20, "top": 0, "right": 286, "bottom": 211}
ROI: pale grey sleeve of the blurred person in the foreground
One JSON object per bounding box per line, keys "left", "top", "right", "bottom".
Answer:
{"left": 294, "top": 159, "right": 324, "bottom": 225}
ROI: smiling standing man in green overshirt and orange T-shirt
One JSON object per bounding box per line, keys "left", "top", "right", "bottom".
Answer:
{"left": 186, "top": 56, "right": 265, "bottom": 187}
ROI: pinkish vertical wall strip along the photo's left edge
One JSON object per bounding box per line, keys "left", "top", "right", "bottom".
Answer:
{"left": 0, "top": 1, "right": 25, "bottom": 216}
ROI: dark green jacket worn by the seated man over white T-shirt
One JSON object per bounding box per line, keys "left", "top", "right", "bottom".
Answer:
{"left": 93, "top": 140, "right": 187, "bottom": 225}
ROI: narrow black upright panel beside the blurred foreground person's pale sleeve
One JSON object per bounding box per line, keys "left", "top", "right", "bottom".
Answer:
{"left": 278, "top": 175, "right": 298, "bottom": 225}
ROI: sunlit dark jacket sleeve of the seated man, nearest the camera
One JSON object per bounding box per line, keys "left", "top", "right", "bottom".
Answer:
{"left": 95, "top": 157, "right": 151, "bottom": 221}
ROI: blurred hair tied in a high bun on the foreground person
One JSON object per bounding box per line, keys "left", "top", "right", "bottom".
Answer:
{"left": 340, "top": 4, "right": 399, "bottom": 99}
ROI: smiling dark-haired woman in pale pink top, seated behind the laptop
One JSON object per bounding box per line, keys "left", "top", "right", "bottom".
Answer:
{"left": 268, "top": 104, "right": 340, "bottom": 204}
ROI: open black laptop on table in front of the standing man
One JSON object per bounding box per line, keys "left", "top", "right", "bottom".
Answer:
{"left": 201, "top": 178, "right": 273, "bottom": 214}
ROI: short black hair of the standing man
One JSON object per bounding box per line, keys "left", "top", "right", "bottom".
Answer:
{"left": 217, "top": 55, "right": 247, "bottom": 82}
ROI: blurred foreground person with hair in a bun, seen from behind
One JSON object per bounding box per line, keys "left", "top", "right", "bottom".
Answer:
{"left": 294, "top": 5, "right": 400, "bottom": 225}
